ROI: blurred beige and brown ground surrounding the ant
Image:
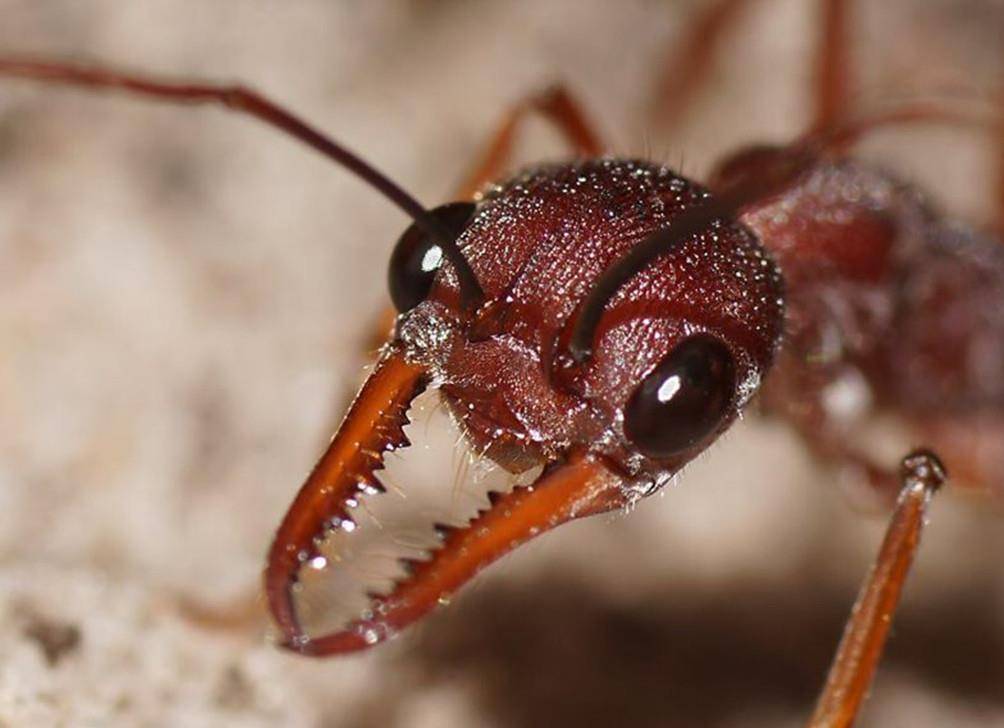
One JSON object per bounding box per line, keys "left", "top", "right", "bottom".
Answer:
{"left": 0, "top": 0, "right": 1004, "bottom": 728}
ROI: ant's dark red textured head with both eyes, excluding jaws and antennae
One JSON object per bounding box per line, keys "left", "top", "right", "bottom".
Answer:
{"left": 391, "top": 160, "right": 782, "bottom": 494}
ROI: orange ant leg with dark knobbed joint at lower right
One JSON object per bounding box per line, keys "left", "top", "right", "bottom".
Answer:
{"left": 807, "top": 450, "right": 946, "bottom": 728}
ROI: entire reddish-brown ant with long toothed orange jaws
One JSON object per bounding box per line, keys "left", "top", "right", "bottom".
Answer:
{"left": 0, "top": 2, "right": 1004, "bottom": 725}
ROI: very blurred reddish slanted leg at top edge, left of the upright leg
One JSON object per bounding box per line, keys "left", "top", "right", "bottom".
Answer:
{"left": 653, "top": 0, "right": 750, "bottom": 129}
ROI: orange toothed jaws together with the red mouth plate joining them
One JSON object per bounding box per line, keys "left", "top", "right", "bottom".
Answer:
{"left": 265, "top": 302, "right": 706, "bottom": 657}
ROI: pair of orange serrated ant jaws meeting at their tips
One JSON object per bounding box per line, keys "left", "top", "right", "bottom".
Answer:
{"left": 265, "top": 348, "right": 633, "bottom": 656}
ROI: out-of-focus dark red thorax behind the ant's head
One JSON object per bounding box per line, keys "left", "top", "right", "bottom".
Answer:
{"left": 741, "top": 160, "right": 1004, "bottom": 447}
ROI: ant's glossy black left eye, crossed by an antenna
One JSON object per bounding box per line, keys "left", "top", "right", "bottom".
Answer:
{"left": 388, "top": 202, "right": 475, "bottom": 313}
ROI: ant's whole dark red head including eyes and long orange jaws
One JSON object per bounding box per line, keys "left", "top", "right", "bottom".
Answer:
{"left": 266, "top": 160, "right": 782, "bottom": 655}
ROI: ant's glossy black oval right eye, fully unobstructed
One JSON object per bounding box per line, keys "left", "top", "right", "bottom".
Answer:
{"left": 624, "top": 334, "right": 736, "bottom": 458}
